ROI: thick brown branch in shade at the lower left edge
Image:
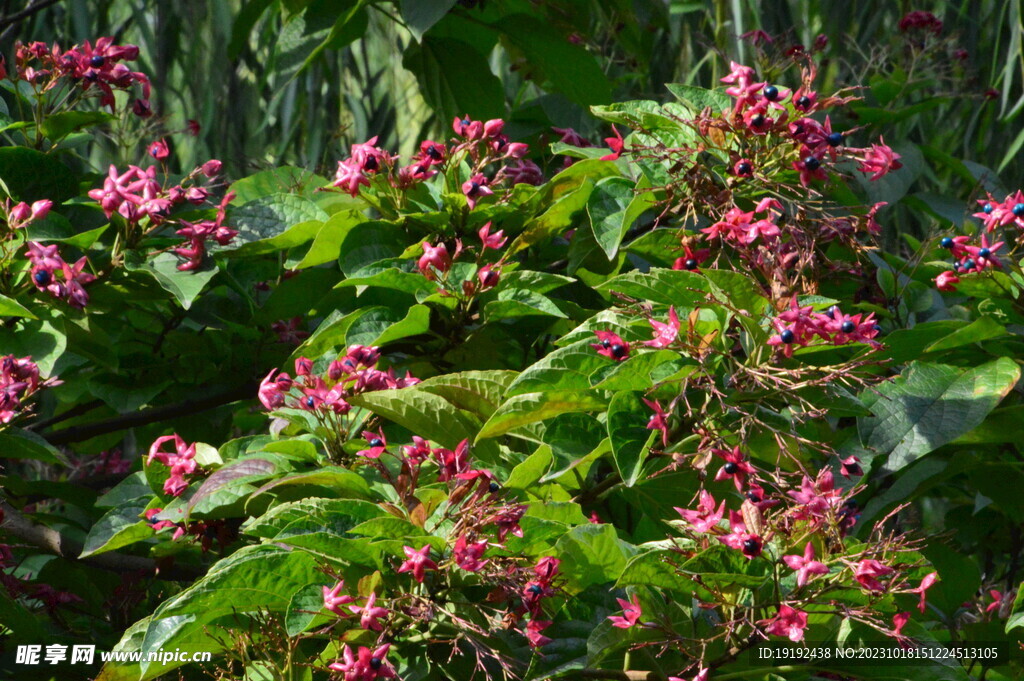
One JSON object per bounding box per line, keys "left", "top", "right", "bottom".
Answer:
{"left": 0, "top": 501, "right": 203, "bottom": 582}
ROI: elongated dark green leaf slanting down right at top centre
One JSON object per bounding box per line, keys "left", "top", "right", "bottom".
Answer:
{"left": 496, "top": 14, "right": 611, "bottom": 107}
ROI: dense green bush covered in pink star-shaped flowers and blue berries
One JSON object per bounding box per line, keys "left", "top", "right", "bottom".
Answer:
{"left": 0, "top": 1, "right": 1024, "bottom": 681}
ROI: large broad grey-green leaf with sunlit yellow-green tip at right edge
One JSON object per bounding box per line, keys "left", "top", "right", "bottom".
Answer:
{"left": 858, "top": 358, "right": 1020, "bottom": 471}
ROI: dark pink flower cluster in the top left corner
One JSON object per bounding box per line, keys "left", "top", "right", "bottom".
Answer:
{"left": 11, "top": 38, "right": 153, "bottom": 118}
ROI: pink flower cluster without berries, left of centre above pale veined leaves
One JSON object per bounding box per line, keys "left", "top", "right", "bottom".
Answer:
{"left": 259, "top": 345, "right": 420, "bottom": 414}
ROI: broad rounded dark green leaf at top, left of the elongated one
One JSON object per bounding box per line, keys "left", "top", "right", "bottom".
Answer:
{"left": 402, "top": 36, "right": 505, "bottom": 123}
